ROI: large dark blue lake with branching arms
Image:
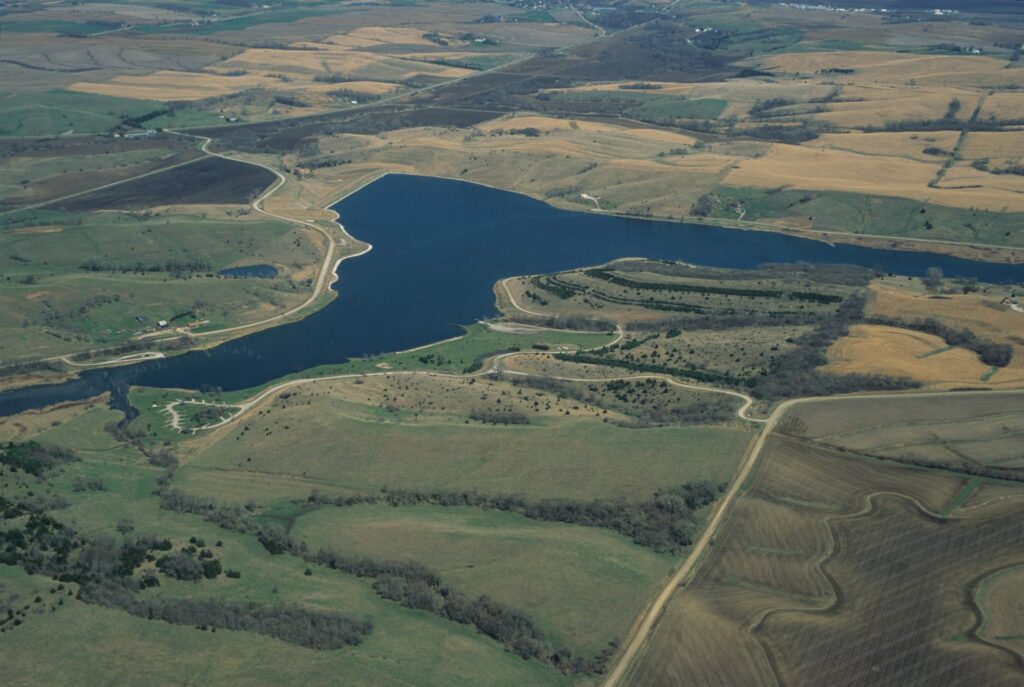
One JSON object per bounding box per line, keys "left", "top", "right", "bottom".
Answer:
{"left": 0, "top": 175, "right": 1024, "bottom": 416}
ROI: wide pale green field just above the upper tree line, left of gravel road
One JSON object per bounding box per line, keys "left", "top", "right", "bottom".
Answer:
{"left": 174, "top": 396, "right": 750, "bottom": 499}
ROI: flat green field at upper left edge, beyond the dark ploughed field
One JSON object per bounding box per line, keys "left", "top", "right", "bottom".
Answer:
{"left": 0, "top": 90, "right": 161, "bottom": 136}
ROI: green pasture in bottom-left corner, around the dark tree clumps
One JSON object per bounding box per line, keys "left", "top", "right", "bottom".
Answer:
{"left": 0, "top": 407, "right": 568, "bottom": 687}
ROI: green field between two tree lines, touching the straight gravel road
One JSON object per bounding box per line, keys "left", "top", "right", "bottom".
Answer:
{"left": 291, "top": 506, "right": 673, "bottom": 654}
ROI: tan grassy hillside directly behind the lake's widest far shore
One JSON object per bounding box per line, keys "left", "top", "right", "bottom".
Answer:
{"left": 311, "top": 115, "right": 738, "bottom": 217}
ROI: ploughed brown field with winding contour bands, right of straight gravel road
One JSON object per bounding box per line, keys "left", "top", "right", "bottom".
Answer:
{"left": 629, "top": 396, "right": 1024, "bottom": 687}
